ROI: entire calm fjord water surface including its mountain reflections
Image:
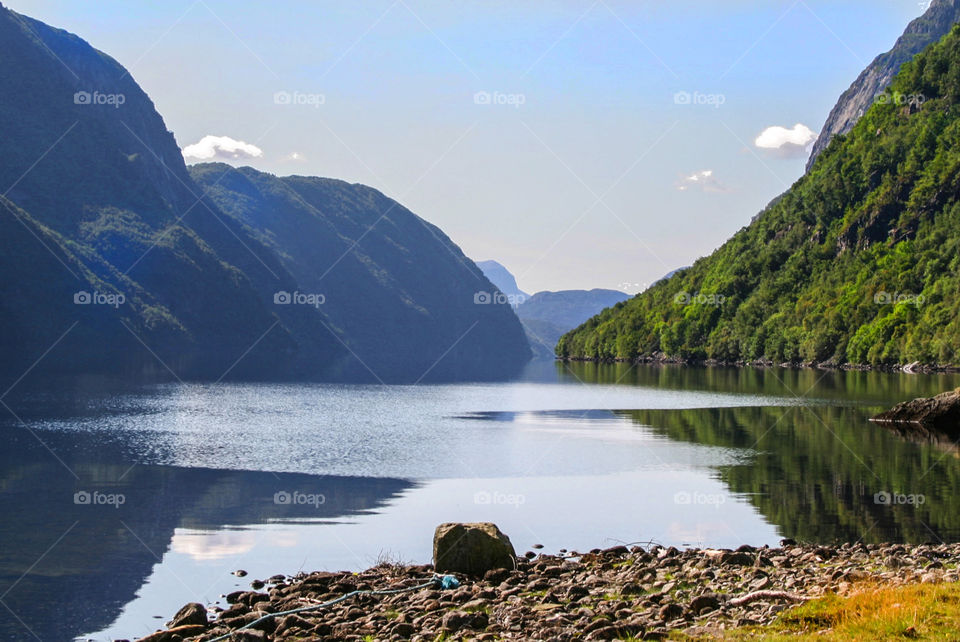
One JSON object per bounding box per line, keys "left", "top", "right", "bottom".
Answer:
{"left": 0, "top": 364, "right": 960, "bottom": 640}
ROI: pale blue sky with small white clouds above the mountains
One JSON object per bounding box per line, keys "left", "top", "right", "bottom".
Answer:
{"left": 4, "top": 0, "right": 924, "bottom": 294}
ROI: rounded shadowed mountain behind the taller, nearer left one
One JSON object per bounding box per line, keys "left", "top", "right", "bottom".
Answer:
{"left": 190, "top": 164, "right": 530, "bottom": 380}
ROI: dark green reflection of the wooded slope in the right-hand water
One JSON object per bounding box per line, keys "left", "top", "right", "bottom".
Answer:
{"left": 617, "top": 406, "right": 960, "bottom": 543}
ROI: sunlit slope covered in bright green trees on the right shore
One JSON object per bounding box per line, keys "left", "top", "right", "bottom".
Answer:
{"left": 557, "top": 27, "right": 960, "bottom": 366}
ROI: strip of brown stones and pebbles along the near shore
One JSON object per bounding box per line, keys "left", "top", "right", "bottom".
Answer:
{"left": 142, "top": 540, "right": 960, "bottom": 642}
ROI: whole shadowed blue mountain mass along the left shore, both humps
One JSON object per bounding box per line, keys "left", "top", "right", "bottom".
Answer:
{"left": 0, "top": 7, "right": 530, "bottom": 381}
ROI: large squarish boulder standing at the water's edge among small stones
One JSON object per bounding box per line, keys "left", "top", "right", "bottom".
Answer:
{"left": 433, "top": 522, "right": 517, "bottom": 576}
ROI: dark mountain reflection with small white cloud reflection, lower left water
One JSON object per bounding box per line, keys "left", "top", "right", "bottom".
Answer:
{"left": 0, "top": 435, "right": 413, "bottom": 640}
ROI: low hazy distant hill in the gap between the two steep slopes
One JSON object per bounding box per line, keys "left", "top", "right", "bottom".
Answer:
{"left": 517, "top": 289, "right": 630, "bottom": 358}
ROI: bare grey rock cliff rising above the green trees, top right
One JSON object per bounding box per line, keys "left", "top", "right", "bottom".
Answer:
{"left": 807, "top": 0, "right": 960, "bottom": 171}
